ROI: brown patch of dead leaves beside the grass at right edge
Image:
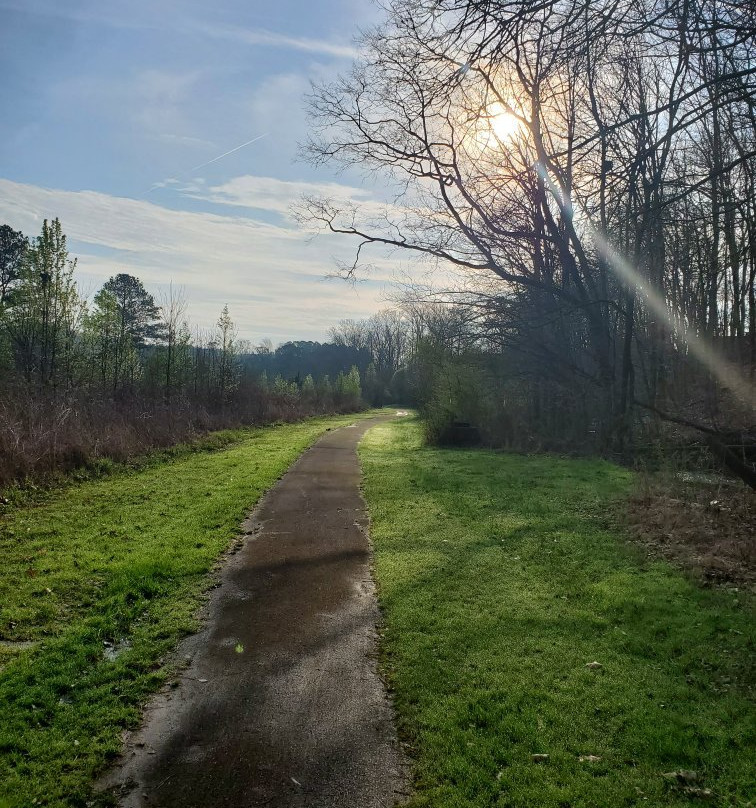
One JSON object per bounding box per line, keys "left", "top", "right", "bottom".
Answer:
{"left": 628, "top": 475, "right": 756, "bottom": 590}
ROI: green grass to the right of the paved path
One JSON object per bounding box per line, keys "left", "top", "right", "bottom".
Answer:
{"left": 361, "top": 419, "right": 756, "bottom": 808}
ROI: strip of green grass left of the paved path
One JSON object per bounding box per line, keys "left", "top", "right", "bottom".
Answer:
{"left": 0, "top": 416, "right": 376, "bottom": 808}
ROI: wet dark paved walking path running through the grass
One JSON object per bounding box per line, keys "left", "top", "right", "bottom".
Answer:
{"left": 107, "top": 419, "right": 406, "bottom": 808}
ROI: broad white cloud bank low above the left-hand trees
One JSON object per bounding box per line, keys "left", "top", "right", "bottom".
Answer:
{"left": 0, "top": 178, "right": 398, "bottom": 341}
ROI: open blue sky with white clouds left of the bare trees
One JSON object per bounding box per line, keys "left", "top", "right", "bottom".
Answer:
{"left": 0, "top": 0, "right": 414, "bottom": 342}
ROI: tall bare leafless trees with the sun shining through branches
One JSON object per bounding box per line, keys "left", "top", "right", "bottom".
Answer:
{"left": 300, "top": 0, "right": 756, "bottom": 482}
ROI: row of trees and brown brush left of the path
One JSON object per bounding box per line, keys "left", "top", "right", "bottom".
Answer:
{"left": 0, "top": 219, "right": 367, "bottom": 484}
